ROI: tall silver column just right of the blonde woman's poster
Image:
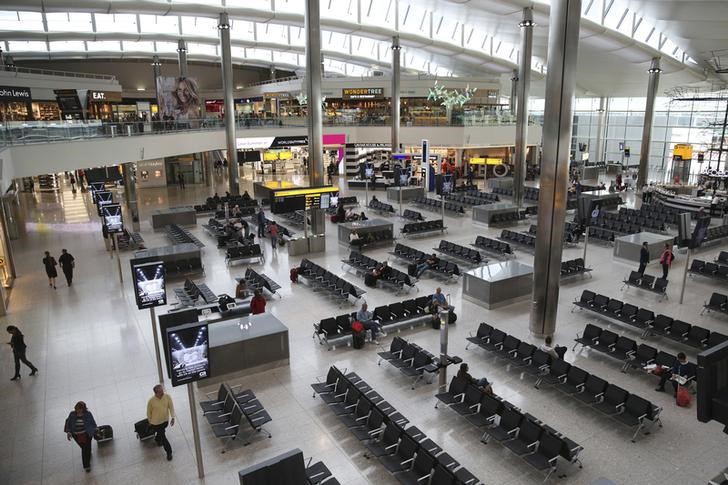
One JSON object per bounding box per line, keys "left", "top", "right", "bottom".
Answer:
{"left": 217, "top": 12, "right": 240, "bottom": 195}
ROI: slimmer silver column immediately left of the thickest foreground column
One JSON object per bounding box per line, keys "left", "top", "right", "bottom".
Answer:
{"left": 513, "top": 7, "right": 536, "bottom": 207}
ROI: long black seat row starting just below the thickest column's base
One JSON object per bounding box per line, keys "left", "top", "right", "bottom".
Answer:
{"left": 468, "top": 323, "right": 662, "bottom": 442}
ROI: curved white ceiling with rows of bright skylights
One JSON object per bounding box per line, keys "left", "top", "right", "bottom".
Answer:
{"left": 0, "top": 0, "right": 716, "bottom": 95}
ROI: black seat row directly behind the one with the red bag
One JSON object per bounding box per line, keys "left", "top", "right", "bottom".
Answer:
{"left": 574, "top": 290, "right": 726, "bottom": 350}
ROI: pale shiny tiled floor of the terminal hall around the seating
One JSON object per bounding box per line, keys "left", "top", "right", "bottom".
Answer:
{"left": 0, "top": 172, "right": 728, "bottom": 485}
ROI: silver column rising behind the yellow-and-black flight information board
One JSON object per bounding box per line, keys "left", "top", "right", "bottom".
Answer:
{"left": 304, "top": 0, "right": 326, "bottom": 234}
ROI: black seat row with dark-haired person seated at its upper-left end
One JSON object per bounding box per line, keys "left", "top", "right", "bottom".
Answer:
{"left": 435, "top": 376, "right": 583, "bottom": 476}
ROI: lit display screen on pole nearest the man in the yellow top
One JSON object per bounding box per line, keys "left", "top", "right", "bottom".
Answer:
{"left": 167, "top": 323, "right": 210, "bottom": 387}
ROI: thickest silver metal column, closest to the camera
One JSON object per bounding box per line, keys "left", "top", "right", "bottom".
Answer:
{"left": 530, "top": 0, "right": 581, "bottom": 336}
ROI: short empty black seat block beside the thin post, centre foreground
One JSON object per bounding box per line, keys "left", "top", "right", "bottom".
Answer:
{"left": 377, "top": 337, "right": 463, "bottom": 389}
